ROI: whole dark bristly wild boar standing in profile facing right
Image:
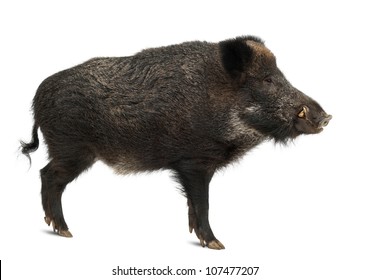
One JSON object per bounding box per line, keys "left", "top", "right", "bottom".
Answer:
{"left": 21, "top": 36, "right": 331, "bottom": 249}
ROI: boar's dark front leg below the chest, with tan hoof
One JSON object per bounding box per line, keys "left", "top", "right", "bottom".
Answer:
{"left": 175, "top": 160, "right": 225, "bottom": 249}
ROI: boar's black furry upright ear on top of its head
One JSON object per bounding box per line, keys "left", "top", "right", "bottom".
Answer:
{"left": 219, "top": 36, "right": 261, "bottom": 80}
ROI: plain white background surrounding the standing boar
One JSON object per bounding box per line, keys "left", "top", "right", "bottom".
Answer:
{"left": 0, "top": 0, "right": 370, "bottom": 280}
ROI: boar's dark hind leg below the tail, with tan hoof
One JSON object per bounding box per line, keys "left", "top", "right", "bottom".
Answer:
{"left": 40, "top": 154, "right": 94, "bottom": 237}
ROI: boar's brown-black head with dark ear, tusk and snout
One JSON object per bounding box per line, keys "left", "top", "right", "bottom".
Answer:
{"left": 220, "top": 36, "right": 332, "bottom": 142}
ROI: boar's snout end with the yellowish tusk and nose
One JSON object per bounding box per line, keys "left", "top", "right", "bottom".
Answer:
{"left": 295, "top": 105, "right": 332, "bottom": 134}
